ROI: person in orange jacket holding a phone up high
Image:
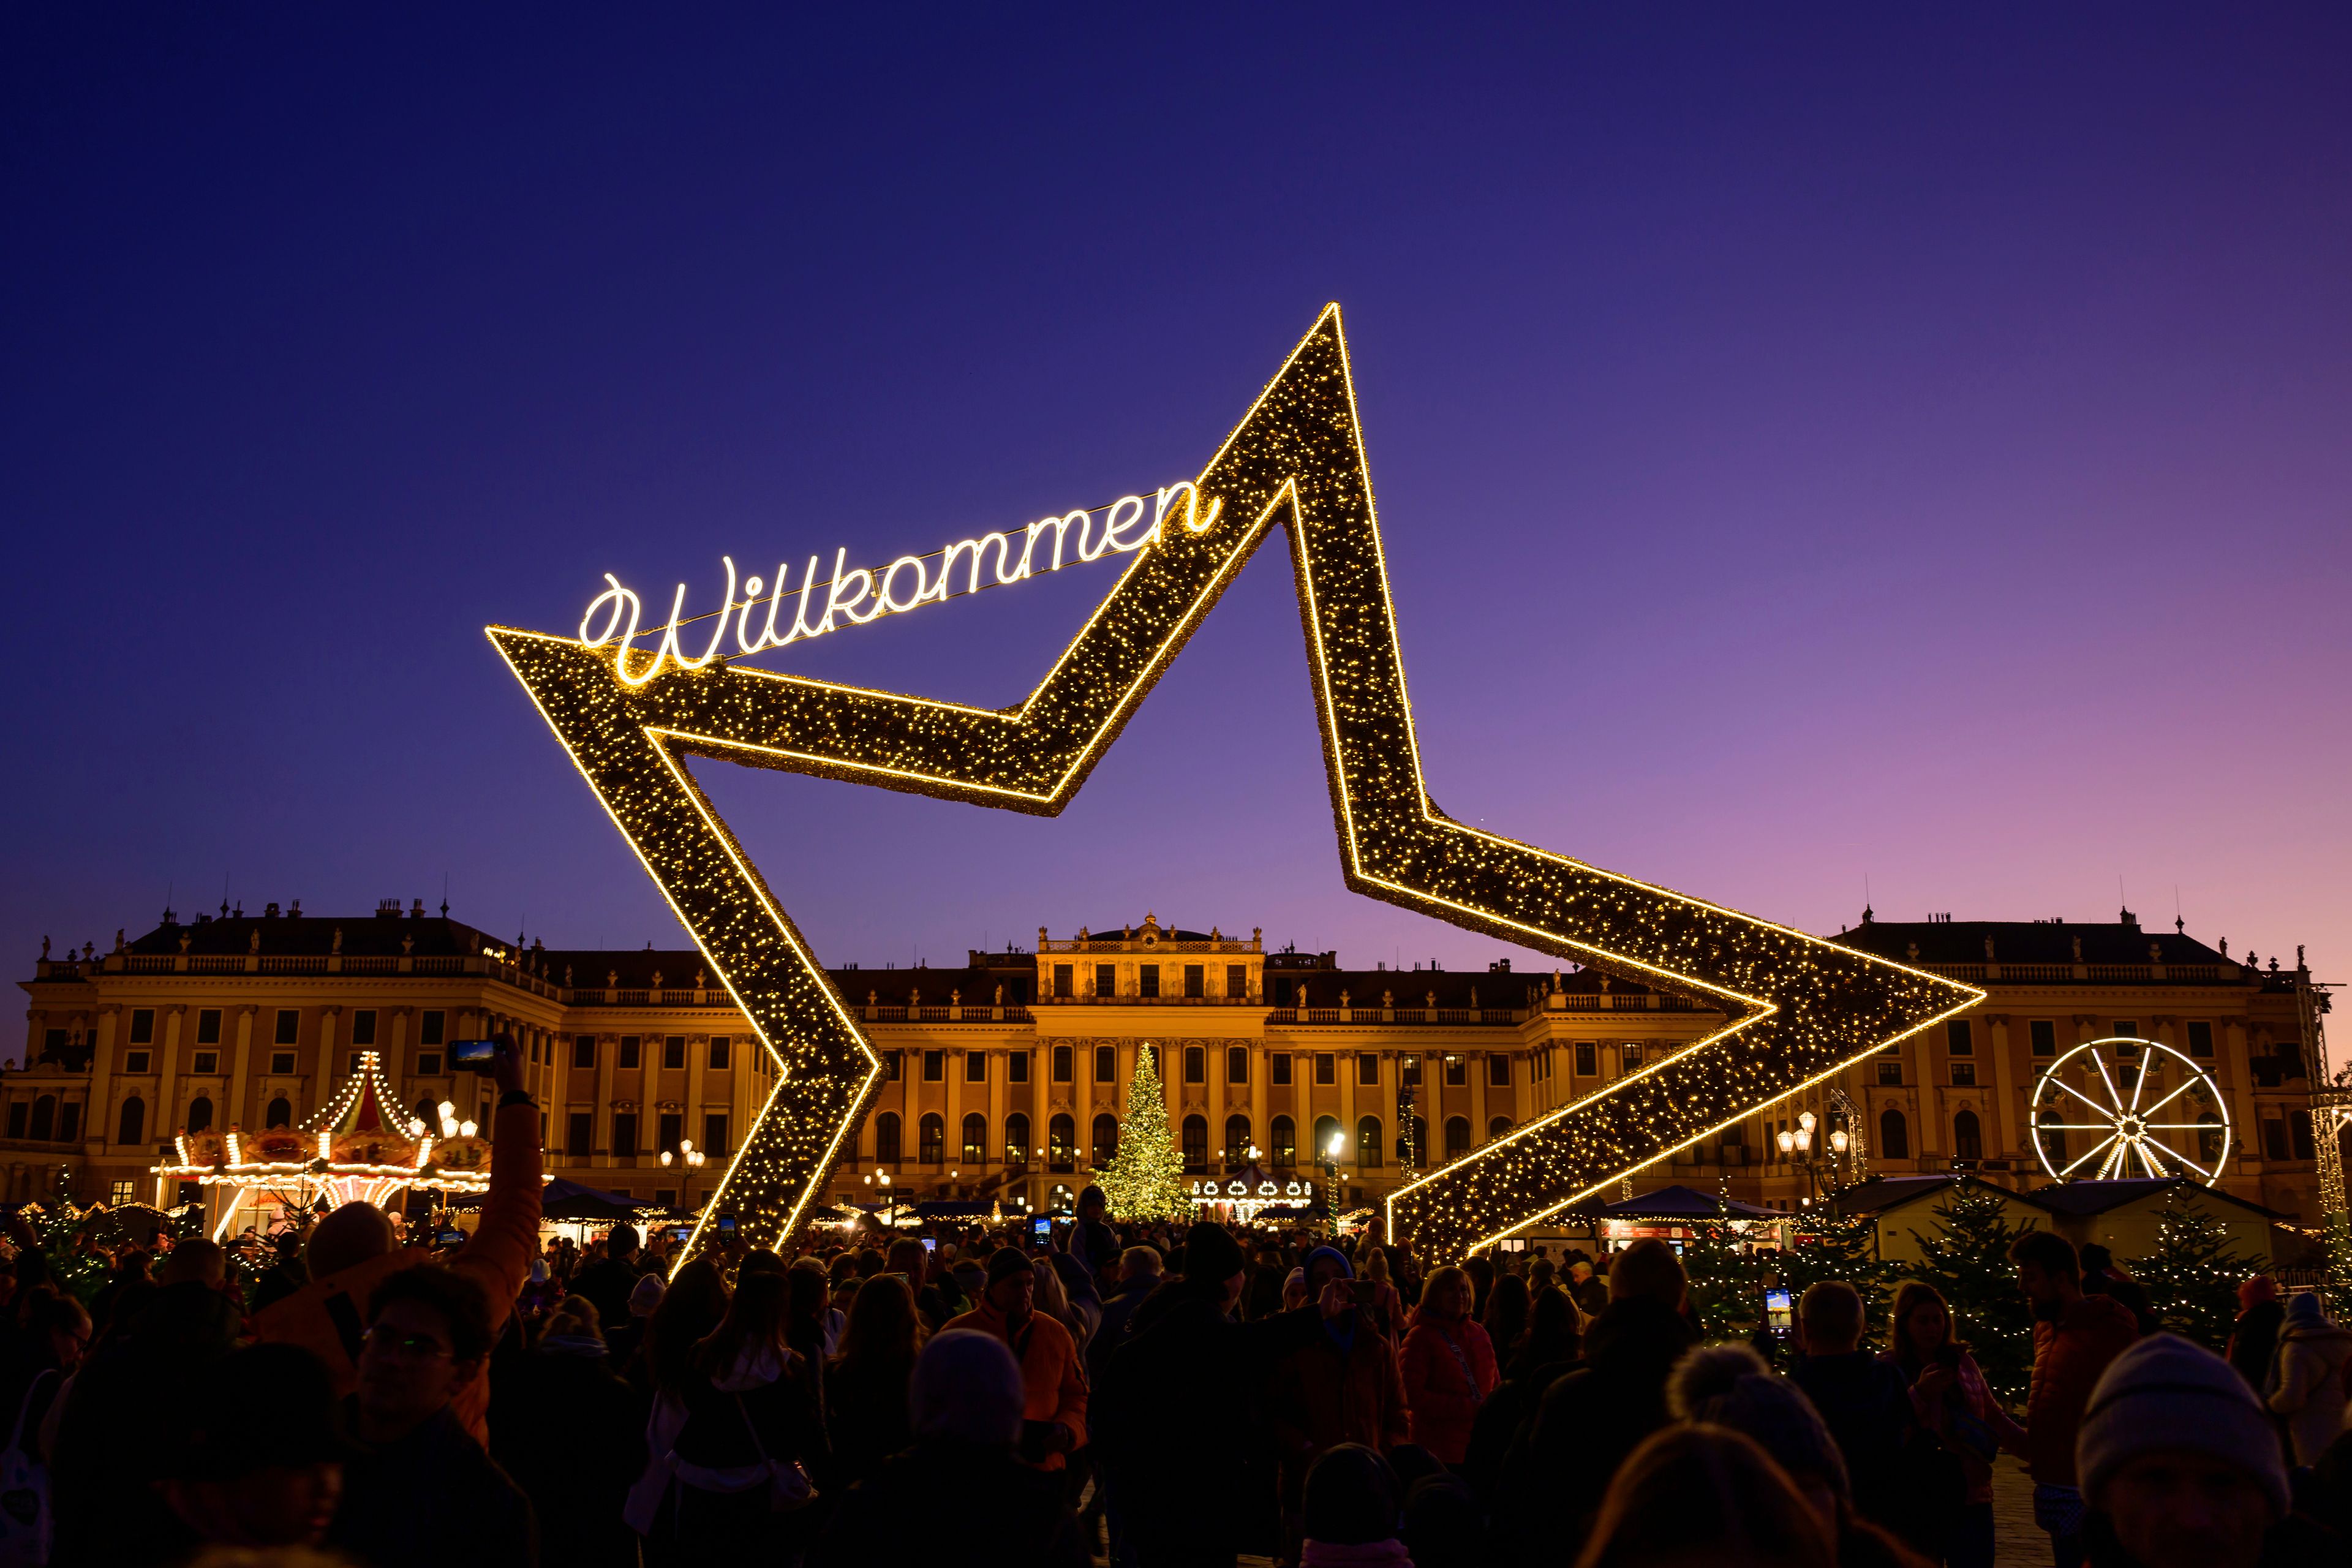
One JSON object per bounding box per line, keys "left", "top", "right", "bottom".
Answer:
{"left": 252, "top": 1035, "right": 541, "bottom": 1444}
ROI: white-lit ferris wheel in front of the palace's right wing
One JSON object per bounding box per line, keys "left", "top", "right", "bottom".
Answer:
{"left": 2032, "top": 1035, "right": 2230, "bottom": 1187}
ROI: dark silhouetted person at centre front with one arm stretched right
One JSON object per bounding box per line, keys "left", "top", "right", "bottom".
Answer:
{"left": 1094, "top": 1223, "right": 1355, "bottom": 1568}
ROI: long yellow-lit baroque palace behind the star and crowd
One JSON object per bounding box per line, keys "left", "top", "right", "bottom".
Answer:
{"left": 13, "top": 900, "right": 2324, "bottom": 1227}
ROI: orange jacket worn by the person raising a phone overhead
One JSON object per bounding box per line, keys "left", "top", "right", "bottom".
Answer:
{"left": 254, "top": 1105, "right": 541, "bottom": 1441}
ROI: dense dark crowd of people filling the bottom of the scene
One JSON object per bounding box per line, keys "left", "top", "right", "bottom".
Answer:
{"left": 0, "top": 1044, "right": 2352, "bottom": 1568}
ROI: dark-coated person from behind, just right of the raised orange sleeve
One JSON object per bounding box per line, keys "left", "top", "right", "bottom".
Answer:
{"left": 489, "top": 1295, "right": 644, "bottom": 1568}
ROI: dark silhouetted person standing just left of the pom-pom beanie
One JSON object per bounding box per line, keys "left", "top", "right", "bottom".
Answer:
{"left": 1493, "top": 1237, "right": 1698, "bottom": 1559}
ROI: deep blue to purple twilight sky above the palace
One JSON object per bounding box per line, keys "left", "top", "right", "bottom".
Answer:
{"left": 13, "top": 5, "right": 2352, "bottom": 978}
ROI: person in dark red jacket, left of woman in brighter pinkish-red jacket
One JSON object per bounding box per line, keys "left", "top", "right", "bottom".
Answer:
{"left": 1272, "top": 1246, "right": 1411, "bottom": 1545}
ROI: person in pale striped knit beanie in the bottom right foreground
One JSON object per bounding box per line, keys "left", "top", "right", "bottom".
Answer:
{"left": 2075, "top": 1333, "right": 2321, "bottom": 1568}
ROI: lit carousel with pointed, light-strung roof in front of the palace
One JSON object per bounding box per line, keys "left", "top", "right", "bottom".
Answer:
{"left": 153, "top": 1051, "right": 489, "bottom": 1239}
